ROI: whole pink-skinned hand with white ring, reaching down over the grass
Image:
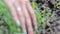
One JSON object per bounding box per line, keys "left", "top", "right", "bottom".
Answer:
{"left": 4, "top": 0, "right": 37, "bottom": 34}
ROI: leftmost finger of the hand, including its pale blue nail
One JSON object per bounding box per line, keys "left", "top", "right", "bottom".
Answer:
{"left": 4, "top": 0, "right": 21, "bottom": 27}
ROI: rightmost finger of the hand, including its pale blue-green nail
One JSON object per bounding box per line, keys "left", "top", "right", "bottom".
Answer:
{"left": 26, "top": 2, "right": 38, "bottom": 31}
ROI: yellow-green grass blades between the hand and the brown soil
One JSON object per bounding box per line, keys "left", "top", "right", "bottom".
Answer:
{"left": 32, "top": 0, "right": 51, "bottom": 33}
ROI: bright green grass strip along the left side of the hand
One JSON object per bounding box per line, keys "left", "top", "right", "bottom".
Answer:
{"left": 0, "top": 0, "right": 20, "bottom": 34}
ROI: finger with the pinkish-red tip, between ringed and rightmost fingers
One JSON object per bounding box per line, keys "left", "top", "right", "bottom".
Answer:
{"left": 21, "top": 2, "right": 33, "bottom": 34}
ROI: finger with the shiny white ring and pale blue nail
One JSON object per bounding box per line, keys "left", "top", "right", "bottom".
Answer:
{"left": 14, "top": 1, "right": 27, "bottom": 34}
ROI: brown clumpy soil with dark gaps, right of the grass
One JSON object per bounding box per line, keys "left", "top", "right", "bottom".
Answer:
{"left": 36, "top": 0, "right": 60, "bottom": 34}
